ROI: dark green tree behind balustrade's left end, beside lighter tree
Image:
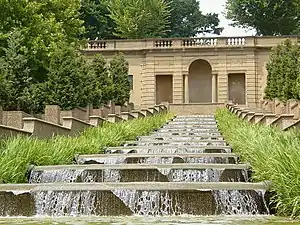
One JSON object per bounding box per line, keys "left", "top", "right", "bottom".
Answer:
{"left": 80, "top": 0, "right": 117, "bottom": 40}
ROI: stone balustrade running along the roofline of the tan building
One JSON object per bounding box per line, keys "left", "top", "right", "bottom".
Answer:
{"left": 84, "top": 36, "right": 298, "bottom": 51}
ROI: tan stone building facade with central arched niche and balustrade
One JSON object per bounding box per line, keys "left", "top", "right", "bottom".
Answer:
{"left": 84, "top": 36, "right": 298, "bottom": 107}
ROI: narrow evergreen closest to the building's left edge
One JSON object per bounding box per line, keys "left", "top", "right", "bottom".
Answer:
{"left": 109, "top": 53, "right": 130, "bottom": 105}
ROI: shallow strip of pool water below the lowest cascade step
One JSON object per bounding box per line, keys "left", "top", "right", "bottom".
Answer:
{"left": 0, "top": 216, "right": 300, "bottom": 225}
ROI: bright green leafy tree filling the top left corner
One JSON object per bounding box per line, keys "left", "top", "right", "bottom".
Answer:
{"left": 0, "top": 0, "right": 84, "bottom": 81}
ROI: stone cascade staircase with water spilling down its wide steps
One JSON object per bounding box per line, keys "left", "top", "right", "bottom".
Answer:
{"left": 0, "top": 116, "right": 268, "bottom": 216}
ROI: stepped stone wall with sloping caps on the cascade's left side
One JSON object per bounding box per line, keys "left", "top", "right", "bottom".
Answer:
{"left": 0, "top": 104, "right": 167, "bottom": 138}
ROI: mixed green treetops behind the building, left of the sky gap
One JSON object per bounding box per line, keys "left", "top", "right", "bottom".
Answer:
{"left": 81, "top": 0, "right": 222, "bottom": 39}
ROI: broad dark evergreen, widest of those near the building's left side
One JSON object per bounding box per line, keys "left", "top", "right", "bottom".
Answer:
{"left": 37, "top": 45, "right": 93, "bottom": 109}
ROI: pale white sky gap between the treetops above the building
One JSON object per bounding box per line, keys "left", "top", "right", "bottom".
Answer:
{"left": 199, "top": 0, "right": 255, "bottom": 37}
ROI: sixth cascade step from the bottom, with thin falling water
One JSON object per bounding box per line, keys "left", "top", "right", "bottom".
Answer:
{"left": 137, "top": 135, "right": 224, "bottom": 142}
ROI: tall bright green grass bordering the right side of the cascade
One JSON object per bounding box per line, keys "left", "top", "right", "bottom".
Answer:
{"left": 216, "top": 109, "right": 300, "bottom": 217}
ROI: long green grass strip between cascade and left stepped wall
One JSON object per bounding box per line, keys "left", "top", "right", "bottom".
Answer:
{"left": 0, "top": 113, "right": 173, "bottom": 183}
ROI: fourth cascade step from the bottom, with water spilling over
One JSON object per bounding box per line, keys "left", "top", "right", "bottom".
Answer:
{"left": 104, "top": 145, "right": 232, "bottom": 154}
